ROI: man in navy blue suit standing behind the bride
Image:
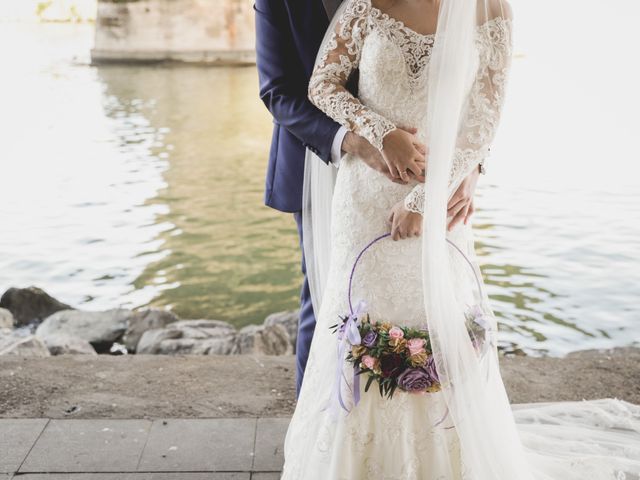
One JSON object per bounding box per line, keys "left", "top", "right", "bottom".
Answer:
{"left": 254, "top": 0, "right": 477, "bottom": 394}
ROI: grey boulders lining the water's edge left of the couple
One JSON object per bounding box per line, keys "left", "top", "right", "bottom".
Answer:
{"left": 0, "top": 287, "right": 298, "bottom": 357}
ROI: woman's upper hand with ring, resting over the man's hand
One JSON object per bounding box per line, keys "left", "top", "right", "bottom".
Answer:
{"left": 382, "top": 128, "right": 427, "bottom": 182}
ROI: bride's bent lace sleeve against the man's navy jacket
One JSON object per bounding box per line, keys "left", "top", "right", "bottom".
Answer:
{"left": 309, "top": 0, "right": 396, "bottom": 150}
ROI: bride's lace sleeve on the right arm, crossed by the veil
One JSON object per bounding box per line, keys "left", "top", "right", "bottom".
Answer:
{"left": 404, "top": 17, "right": 512, "bottom": 213}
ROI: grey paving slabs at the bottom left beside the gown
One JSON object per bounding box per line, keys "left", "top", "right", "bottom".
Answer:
{"left": 0, "top": 418, "right": 289, "bottom": 480}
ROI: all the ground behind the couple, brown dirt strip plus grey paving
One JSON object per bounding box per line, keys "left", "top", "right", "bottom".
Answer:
{"left": 0, "top": 349, "right": 640, "bottom": 480}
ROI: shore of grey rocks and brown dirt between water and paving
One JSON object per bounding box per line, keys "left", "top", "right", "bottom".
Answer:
{"left": 0, "top": 287, "right": 640, "bottom": 418}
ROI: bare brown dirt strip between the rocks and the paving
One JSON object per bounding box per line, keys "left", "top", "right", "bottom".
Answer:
{"left": 0, "top": 349, "right": 640, "bottom": 418}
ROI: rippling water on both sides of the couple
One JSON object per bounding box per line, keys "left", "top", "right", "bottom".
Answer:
{"left": 0, "top": 14, "right": 640, "bottom": 355}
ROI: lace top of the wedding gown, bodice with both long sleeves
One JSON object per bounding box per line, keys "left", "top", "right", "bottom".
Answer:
{"left": 309, "top": 0, "right": 512, "bottom": 213}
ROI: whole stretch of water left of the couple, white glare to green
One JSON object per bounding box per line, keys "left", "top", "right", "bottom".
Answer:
{"left": 0, "top": 25, "right": 300, "bottom": 325}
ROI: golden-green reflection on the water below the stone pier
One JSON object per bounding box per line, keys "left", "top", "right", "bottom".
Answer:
{"left": 97, "top": 66, "right": 299, "bottom": 324}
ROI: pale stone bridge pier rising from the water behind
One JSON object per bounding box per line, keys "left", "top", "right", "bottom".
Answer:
{"left": 91, "top": 0, "right": 255, "bottom": 65}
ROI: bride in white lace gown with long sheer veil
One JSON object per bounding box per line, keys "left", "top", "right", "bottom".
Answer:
{"left": 282, "top": 0, "right": 640, "bottom": 480}
